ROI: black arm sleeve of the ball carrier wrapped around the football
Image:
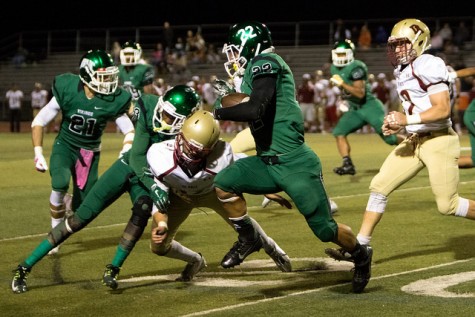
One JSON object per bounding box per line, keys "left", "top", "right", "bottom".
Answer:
{"left": 214, "top": 75, "right": 277, "bottom": 121}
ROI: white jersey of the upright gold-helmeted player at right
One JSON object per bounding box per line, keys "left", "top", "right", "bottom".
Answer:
{"left": 394, "top": 54, "right": 452, "bottom": 133}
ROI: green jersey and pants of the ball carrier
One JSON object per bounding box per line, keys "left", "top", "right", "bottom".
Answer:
{"left": 215, "top": 53, "right": 337, "bottom": 241}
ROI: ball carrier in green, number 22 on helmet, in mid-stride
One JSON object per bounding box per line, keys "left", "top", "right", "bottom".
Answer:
{"left": 214, "top": 22, "right": 372, "bottom": 293}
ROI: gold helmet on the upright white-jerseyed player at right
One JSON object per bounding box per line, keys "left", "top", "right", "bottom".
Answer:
{"left": 387, "top": 19, "right": 430, "bottom": 67}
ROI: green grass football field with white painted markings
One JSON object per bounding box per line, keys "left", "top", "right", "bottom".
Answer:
{"left": 0, "top": 133, "right": 475, "bottom": 317}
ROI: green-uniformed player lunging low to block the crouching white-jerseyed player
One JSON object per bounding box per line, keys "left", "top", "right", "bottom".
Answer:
{"left": 12, "top": 85, "right": 200, "bottom": 293}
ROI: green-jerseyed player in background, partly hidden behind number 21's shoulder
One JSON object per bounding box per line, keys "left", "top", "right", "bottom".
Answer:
{"left": 119, "top": 41, "right": 156, "bottom": 99}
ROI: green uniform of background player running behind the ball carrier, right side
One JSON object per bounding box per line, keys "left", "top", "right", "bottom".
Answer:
{"left": 330, "top": 60, "right": 397, "bottom": 145}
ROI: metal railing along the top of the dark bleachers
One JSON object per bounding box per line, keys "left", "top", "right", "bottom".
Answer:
{"left": 0, "top": 17, "right": 475, "bottom": 62}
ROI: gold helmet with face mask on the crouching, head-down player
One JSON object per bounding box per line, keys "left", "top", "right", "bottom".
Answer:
{"left": 174, "top": 110, "right": 220, "bottom": 170}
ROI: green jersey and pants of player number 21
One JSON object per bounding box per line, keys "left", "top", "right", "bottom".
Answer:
{"left": 50, "top": 73, "right": 131, "bottom": 210}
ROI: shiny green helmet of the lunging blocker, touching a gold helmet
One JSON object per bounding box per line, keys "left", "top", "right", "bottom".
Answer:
{"left": 153, "top": 85, "right": 201, "bottom": 135}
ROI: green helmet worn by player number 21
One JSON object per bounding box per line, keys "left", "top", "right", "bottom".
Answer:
{"left": 79, "top": 50, "right": 119, "bottom": 95}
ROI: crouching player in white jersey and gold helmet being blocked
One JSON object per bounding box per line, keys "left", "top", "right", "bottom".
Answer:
{"left": 141, "top": 110, "right": 291, "bottom": 282}
